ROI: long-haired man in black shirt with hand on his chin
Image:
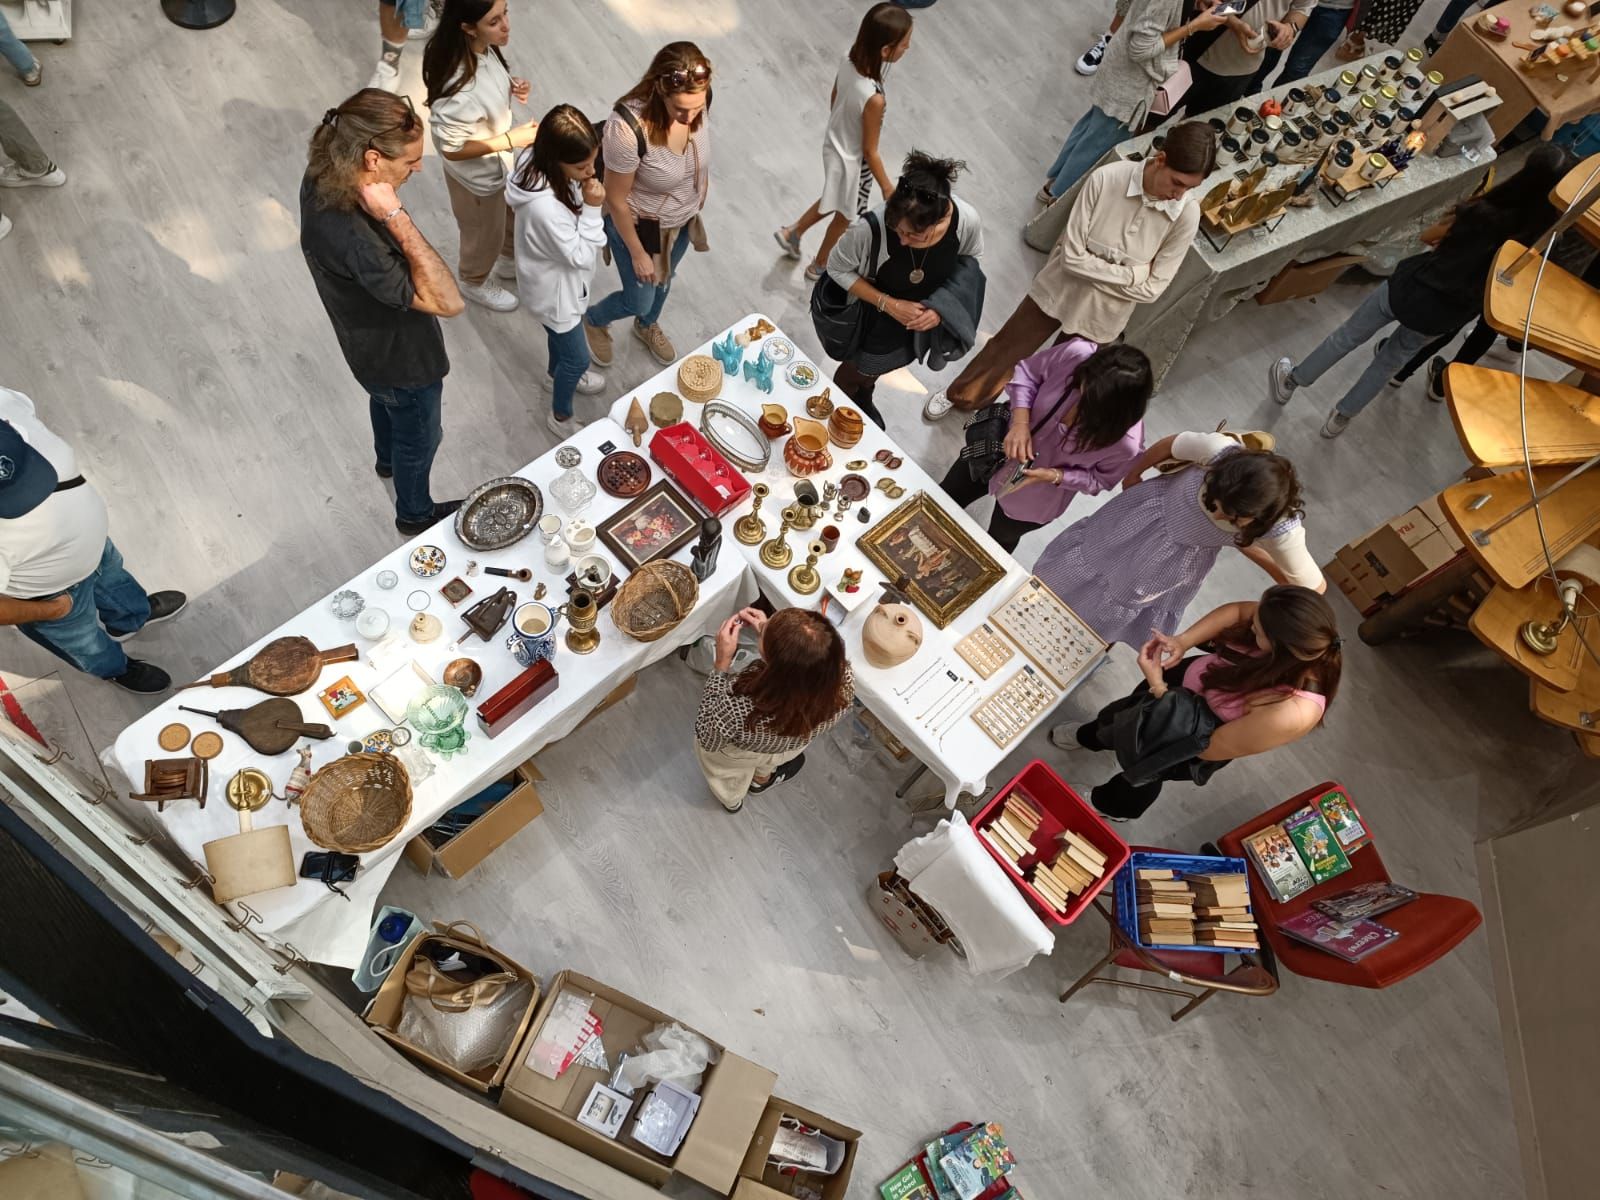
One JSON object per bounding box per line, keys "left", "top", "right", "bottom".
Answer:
{"left": 301, "top": 96, "right": 464, "bottom": 536}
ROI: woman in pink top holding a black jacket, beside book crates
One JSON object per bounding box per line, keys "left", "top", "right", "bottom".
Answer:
{"left": 1050, "top": 584, "right": 1344, "bottom": 821}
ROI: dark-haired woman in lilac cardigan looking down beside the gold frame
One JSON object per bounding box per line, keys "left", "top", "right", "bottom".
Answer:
{"left": 939, "top": 338, "right": 1154, "bottom": 554}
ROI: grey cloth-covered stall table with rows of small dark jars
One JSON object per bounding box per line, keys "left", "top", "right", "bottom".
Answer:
{"left": 1024, "top": 51, "right": 1494, "bottom": 386}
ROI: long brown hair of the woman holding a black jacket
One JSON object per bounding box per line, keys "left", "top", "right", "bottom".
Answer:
{"left": 1202, "top": 584, "right": 1344, "bottom": 720}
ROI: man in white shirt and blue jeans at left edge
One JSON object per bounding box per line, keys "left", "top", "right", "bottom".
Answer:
{"left": 0, "top": 387, "right": 187, "bottom": 694}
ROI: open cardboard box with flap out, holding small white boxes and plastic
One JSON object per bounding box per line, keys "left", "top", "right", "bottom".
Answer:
{"left": 499, "top": 971, "right": 778, "bottom": 1195}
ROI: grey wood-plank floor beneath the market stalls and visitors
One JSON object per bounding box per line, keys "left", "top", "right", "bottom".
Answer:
{"left": 0, "top": 0, "right": 1592, "bottom": 1198}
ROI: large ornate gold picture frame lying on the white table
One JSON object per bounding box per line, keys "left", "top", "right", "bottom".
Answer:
{"left": 856, "top": 491, "right": 1005, "bottom": 629}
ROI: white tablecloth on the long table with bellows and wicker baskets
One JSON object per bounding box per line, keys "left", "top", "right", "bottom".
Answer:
{"left": 104, "top": 421, "right": 755, "bottom": 965}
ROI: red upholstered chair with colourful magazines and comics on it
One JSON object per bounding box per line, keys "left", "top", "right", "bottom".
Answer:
{"left": 1216, "top": 782, "right": 1483, "bottom": 987}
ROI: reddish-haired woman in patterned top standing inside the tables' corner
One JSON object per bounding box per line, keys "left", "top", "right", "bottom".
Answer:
{"left": 694, "top": 608, "right": 854, "bottom": 813}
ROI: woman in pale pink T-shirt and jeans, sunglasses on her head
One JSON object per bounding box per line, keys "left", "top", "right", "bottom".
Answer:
{"left": 584, "top": 42, "right": 710, "bottom": 366}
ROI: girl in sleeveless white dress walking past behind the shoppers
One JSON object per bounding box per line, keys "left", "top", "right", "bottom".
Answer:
{"left": 773, "top": 3, "right": 912, "bottom": 282}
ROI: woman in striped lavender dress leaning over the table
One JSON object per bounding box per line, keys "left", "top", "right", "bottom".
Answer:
{"left": 1034, "top": 434, "right": 1326, "bottom": 646}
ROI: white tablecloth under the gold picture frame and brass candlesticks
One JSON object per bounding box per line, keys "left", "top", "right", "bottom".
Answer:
{"left": 611, "top": 314, "right": 1094, "bottom": 808}
